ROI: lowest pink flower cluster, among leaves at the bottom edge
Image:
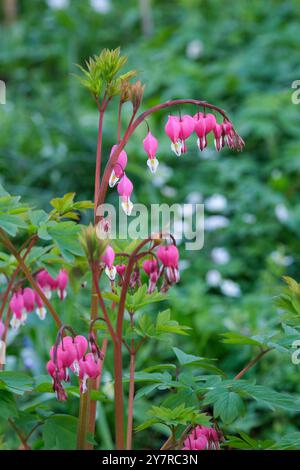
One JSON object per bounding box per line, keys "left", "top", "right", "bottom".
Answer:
{"left": 182, "top": 426, "right": 220, "bottom": 450}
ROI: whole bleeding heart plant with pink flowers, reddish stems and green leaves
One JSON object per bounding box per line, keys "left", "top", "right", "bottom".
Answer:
{"left": 13, "top": 49, "right": 300, "bottom": 450}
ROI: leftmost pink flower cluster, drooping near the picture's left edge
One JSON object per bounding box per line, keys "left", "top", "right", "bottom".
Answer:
{"left": 9, "top": 269, "right": 68, "bottom": 329}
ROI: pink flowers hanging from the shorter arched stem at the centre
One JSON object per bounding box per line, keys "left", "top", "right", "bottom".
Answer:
{"left": 101, "top": 244, "right": 179, "bottom": 294}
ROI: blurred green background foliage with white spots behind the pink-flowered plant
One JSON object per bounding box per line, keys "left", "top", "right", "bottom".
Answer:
{"left": 0, "top": 0, "right": 300, "bottom": 447}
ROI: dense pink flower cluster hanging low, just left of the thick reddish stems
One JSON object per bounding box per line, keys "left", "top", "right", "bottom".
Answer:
{"left": 46, "top": 335, "right": 103, "bottom": 401}
